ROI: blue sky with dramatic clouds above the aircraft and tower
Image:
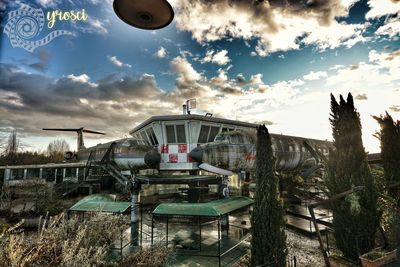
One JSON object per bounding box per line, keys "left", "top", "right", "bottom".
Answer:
{"left": 0, "top": 0, "right": 400, "bottom": 153}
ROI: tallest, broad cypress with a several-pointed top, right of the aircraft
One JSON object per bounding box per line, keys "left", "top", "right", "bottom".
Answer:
{"left": 326, "top": 93, "right": 379, "bottom": 260}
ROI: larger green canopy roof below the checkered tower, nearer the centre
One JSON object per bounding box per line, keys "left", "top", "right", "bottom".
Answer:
{"left": 153, "top": 196, "right": 253, "bottom": 217}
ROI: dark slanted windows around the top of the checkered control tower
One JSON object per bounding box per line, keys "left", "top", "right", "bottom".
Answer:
{"left": 133, "top": 124, "right": 241, "bottom": 146}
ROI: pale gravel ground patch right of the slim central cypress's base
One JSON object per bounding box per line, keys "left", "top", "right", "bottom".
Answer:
{"left": 286, "top": 230, "right": 325, "bottom": 267}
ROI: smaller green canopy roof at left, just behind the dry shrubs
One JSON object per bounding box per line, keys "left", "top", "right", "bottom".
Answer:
{"left": 68, "top": 194, "right": 131, "bottom": 213}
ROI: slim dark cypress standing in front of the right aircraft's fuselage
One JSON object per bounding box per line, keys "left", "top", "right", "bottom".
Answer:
{"left": 251, "top": 125, "right": 287, "bottom": 267}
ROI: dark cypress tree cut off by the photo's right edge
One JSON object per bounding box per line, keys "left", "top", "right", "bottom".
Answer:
{"left": 373, "top": 112, "right": 400, "bottom": 199}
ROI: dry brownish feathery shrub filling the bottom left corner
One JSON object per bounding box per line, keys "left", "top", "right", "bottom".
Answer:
{"left": 0, "top": 214, "right": 123, "bottom": 267}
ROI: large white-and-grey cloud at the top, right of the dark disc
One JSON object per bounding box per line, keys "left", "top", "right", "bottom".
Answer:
{"left": 176, "top": 0, "right": 365, "bottom": 56}
